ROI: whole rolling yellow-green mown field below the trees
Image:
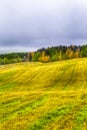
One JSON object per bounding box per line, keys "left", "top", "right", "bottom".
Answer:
{"left": 0, "top": 58, "right": 87, "bottom": 130}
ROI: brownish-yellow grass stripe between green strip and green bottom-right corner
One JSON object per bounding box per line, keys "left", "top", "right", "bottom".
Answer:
{"left": 47, "top": 99, "right": 86, "bottom": 130}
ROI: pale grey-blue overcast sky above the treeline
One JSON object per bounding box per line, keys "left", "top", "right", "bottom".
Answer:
{"left": 0, "top": 0, "right": 87, "bottom": 51}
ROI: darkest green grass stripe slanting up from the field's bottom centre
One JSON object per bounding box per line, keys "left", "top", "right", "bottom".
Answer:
{"left": 27, "top": 104, "right": 73, "bottom": 130}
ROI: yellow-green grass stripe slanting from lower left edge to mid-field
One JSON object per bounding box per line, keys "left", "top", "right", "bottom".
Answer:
{"left": 0, "top": 95, "right": 48, "bottom": 122}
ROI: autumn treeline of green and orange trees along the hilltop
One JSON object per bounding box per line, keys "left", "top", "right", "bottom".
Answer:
{"left": 0, "top": 45, "right": 87, "bottom": 65}
